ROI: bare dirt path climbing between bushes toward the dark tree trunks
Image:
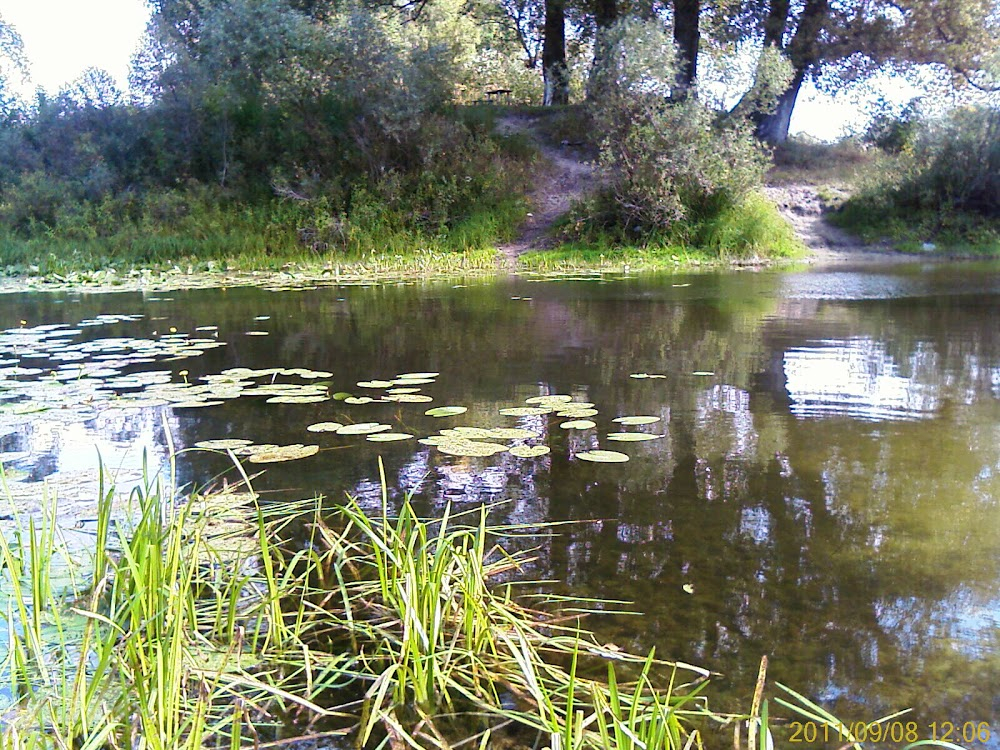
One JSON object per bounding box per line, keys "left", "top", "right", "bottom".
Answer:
{"left": 497, "top": 114, "right": 597, "bottom": 271}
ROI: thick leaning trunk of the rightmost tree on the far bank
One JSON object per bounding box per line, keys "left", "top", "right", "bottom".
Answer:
{"left": 755, "top": 0, "right": 830, "bottom": 144}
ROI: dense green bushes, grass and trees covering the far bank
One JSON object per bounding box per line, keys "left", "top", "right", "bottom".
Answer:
{"left": 0, "top": 0, "right": 996, "bottom": 273}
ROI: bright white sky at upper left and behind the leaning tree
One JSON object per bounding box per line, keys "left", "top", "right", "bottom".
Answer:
{"left": 0, "top": 0, "right": 907, "bottom": 140}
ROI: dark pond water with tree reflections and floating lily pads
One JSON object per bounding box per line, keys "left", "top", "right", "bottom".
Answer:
{"left": 0, "top": 265, "right": 1000, "bottom": 747}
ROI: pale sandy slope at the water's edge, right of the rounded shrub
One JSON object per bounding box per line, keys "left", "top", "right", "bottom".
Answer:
{"left": 764, "top": 185, "right": 913, "bottom": 265}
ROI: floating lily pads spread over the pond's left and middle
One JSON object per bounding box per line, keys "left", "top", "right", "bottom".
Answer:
{"left": 0, "top": 315, "right": 662, "bottom": 470}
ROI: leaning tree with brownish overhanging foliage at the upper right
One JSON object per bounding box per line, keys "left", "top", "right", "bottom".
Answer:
{"left": 733, "top": 0, "right": 997, "bottom": 143}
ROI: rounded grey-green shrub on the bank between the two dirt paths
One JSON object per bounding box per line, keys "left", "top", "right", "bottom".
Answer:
{"left": 592, "top": 19, "right": 777, "bottom": 239}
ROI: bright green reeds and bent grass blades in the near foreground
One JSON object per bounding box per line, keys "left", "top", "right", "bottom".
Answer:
{"left": 0, "top": 452, "right": 860, "bottom": 750}
